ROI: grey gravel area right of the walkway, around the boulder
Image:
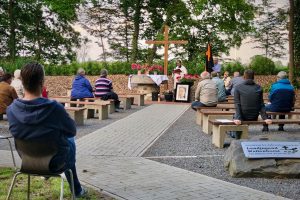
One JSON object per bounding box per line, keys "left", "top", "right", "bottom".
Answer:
{"left": 143, "top": 109, "right": 300, "bottom": 200}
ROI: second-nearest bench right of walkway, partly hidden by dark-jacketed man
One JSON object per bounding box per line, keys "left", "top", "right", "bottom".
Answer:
{"left": 200, "top": 110, "right": 300, "bottom": 134}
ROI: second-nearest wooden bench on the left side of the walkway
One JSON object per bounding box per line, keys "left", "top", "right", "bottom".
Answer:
{"left": 58, "top": 100, "right": 110, "bottom": 120}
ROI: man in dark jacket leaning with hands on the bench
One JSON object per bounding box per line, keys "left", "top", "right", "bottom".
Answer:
{"left": 231, "top": 70, "right": 272, "bottom": 139}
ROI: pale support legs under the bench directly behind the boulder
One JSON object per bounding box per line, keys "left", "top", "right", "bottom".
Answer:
{"left": 212, "top": 125, "right": 248, "bottom": 148}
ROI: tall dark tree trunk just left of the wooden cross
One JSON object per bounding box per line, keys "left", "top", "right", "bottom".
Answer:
{"left": 131, "top": 0, "right": 143, "bottom": 62}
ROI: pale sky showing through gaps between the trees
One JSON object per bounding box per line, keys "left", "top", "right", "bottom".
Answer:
{"left": 74, "top": 0, "right": 289, "bottom": 65}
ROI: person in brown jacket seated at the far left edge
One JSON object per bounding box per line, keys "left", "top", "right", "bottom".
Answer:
{"left": 0, "top": 74, "right": 18, "bottom": 114}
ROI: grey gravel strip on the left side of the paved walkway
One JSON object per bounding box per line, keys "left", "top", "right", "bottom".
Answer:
{"left": 0, "top": 105, "right": 144, "bottom": 150}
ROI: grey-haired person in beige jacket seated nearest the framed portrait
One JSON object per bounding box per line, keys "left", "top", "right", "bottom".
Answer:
{"left": 192, "top": 71, "right": 218, "bottom": 110}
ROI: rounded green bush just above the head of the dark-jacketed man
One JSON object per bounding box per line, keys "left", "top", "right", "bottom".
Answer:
{"left": 249, "top": 55, "right": 275, "bottom": 75}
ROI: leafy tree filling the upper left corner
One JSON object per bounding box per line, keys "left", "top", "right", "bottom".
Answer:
{"left": 0, "top": 0, "right": 81, "bottom": 62}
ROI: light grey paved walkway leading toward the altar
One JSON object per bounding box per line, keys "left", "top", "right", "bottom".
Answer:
{"left": 0, "top": 105, "right": 290, "bottom": 200}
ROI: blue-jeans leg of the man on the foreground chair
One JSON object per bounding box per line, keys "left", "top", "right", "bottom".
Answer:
{"left": 65, "top": 137, "right": 82, "bottom": 196}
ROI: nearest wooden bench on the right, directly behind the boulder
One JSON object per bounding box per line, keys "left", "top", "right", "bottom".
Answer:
{"left": 209, "top": 119, "right": 300, "bottom": 148}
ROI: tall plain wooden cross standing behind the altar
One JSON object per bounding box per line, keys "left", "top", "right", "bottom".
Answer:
{"left": 146, "top": 25, "right": 188, "bottom": 75}
